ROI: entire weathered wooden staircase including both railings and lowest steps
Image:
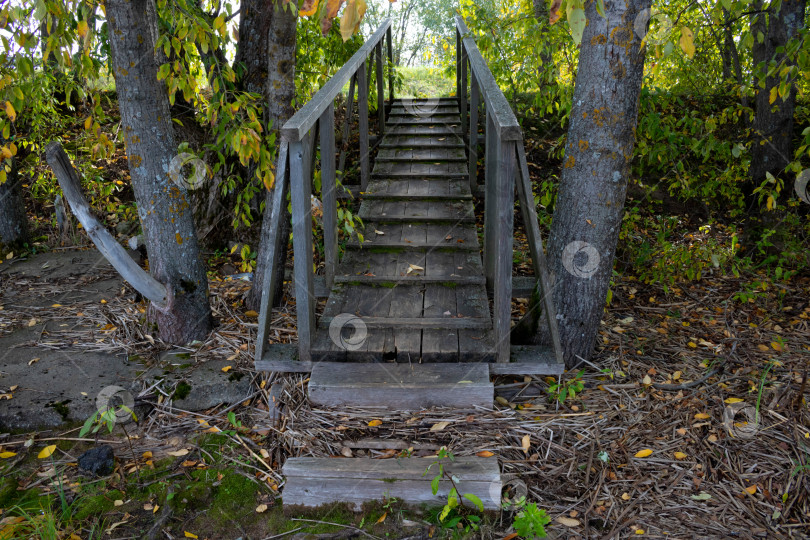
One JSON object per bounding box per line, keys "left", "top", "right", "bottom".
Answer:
{"left": 255, "top": 17, "right": 564, "bottom": 509}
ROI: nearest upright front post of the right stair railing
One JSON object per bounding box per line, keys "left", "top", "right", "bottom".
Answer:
{"left": 493, "top": 137, "right": 515, "bottom": 362}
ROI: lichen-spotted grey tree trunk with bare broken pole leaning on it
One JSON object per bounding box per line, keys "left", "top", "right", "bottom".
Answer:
{"left": 106, "top": 0, "right": 213, "bottom": 344}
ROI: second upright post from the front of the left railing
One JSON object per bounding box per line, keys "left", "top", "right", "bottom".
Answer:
{"left": 319, "top": 106, "right": 338, "bottom": 288}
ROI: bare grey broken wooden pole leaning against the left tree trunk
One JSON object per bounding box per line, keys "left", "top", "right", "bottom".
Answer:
{"left": 45, "top": 142, "right": 170, "bottom": 309}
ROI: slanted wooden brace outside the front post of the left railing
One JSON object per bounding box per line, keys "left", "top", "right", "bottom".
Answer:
{"left": 254, "top": 141, "right": 289, "bottom": 360}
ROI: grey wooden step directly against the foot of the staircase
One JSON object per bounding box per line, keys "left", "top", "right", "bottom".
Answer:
{"left": 309, "top": 362, "right": 495, "bottom": 410}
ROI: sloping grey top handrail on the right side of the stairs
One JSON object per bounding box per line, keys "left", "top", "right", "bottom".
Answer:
{"left": 456, "top": 15, "right": 523, "bottom": 141}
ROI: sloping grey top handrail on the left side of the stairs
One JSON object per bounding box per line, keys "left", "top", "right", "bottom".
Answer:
{"left": 281, "top": 19, "right": 391, "bottom": 142}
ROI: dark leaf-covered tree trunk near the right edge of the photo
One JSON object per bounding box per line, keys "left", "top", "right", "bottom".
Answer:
{"left": 745, "top": 0, "right": 806, "bottom": 211}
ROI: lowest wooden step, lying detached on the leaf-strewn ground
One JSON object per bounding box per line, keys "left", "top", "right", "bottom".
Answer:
{"left": 282, "top": 457, "right": 503, "bottom": 510}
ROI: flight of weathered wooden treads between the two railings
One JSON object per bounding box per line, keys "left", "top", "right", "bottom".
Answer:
{"left": 312, "top": 99, "right": 494, "bottom": 363}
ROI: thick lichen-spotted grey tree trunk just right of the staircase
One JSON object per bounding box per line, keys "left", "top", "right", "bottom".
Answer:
{"left": 548, "top": 0, "right": 651, "bottom": 367}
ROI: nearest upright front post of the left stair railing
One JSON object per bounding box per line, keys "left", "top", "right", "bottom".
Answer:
{"left": 290, "top": 133, "right": 315, "bottom": 362}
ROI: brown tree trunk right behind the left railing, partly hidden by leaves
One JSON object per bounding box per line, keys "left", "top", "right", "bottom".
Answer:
{"left": 246, "top": 0, "right": 298, "bottom": 309}
